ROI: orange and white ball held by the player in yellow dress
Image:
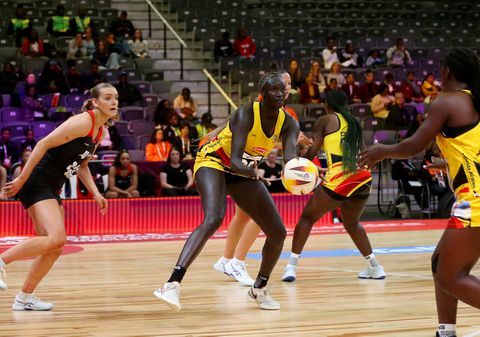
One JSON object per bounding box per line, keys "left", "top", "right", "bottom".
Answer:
{"left": 282, "top": 158, "right": 320, "bottom": 195}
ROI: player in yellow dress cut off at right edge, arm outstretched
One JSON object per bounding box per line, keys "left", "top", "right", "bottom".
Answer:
{"left": 359, "top": 49, "right": 480, "bottom": 337}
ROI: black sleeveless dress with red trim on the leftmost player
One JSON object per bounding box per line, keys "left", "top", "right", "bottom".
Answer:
{"left": 17, "top": 111, "right": 103, "bottom": 208}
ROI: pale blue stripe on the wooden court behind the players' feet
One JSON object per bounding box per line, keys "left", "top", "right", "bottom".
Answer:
{"left": 247, "top": 246, "right": 435, "bottom": 260}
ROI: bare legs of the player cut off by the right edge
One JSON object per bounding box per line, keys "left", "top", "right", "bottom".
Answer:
{"left": 432, "top": 227, "right": 480, "bottom": 324}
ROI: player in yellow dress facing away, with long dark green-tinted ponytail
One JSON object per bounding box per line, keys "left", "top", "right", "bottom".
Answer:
{"left": 282, "top": 90, "right": 385, "bottom": 282}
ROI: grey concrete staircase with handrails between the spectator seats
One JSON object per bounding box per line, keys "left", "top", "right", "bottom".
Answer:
{"left": 112, "top": 0, "right": 238, "bottom": 125}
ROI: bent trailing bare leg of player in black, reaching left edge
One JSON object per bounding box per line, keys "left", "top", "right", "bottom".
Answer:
{"left": 0, "top": 199, "right": 66, "bottom": 264}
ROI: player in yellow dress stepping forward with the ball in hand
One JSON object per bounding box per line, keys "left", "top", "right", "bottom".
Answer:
{"left": 154, "top": 72, "right": 299, "bottom": 310}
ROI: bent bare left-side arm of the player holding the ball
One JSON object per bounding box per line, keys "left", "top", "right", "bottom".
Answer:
{"left": 230, "top": 106, "right": 257, "bottom": 178}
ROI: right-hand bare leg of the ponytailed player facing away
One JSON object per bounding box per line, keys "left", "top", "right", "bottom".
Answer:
{"left": 341, "top": 198, "right": 372, "bottom": 256}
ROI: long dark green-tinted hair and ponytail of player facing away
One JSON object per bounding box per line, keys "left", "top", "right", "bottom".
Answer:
{"left": 326, "top": 90, "right": 363, "bottom": 172}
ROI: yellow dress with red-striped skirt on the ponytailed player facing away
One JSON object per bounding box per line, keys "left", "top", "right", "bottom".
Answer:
{"left": 322, "top": 113, "right": 372, "bottom": 200}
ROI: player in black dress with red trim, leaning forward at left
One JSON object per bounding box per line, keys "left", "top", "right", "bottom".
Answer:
{"left": 0, "top": 83, "right": 118, "bottom": 311}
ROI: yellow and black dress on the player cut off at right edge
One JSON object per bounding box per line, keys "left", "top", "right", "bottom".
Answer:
{"left": 436, "top": 90, "right": 480, "bottom": 228}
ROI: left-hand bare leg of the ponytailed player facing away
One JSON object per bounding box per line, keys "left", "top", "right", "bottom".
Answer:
{"left": 292, "top": 187, "right": 342, "bottom": 254}
